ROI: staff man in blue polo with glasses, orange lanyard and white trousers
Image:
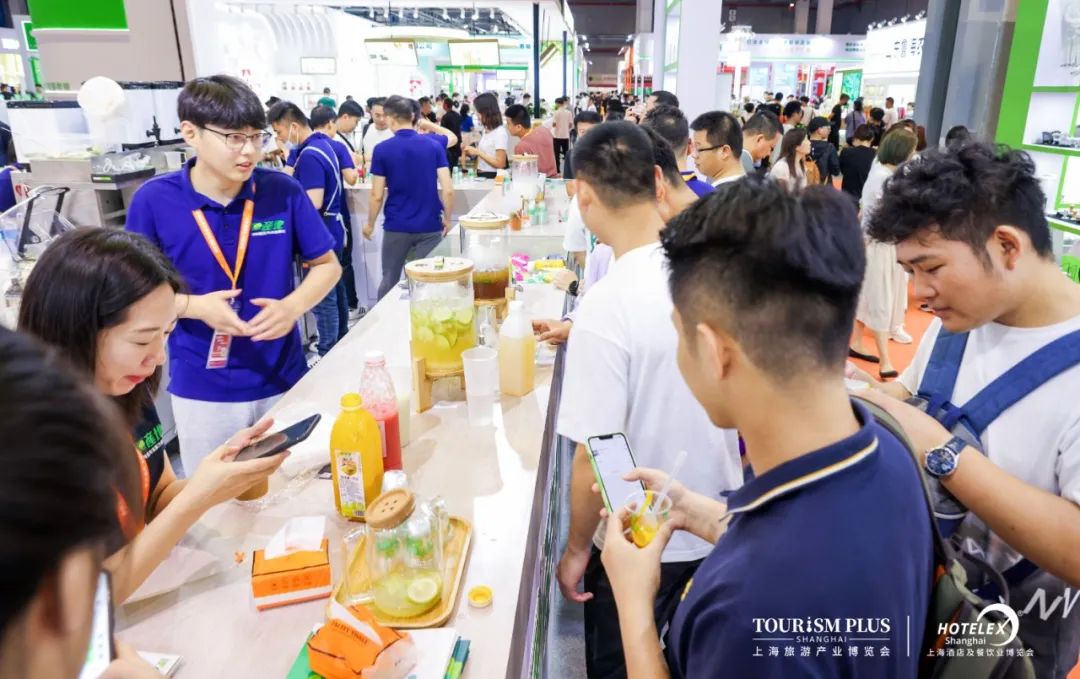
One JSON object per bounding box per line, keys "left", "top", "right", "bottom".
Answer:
{"left": 126, "top": 76, "right": 341, "bottom": 473}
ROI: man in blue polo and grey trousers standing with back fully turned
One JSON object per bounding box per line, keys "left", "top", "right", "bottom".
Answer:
{"left": 364, "top": 96, "right": 454, "bottom": 299}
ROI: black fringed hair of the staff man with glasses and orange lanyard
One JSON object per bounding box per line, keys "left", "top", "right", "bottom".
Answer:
{"left": 176, "top": 76, "right": 267, "bottom": 130}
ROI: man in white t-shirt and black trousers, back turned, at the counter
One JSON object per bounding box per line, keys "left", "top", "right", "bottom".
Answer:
{"left": 557, "top": 122, "right": 742, "bottom": 677}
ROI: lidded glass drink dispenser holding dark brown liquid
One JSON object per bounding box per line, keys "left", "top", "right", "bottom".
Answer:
{"left": 458, "top": 213, "right": 512, "bottom": 304}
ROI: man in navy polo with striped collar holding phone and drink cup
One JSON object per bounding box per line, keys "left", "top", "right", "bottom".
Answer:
{"left": 603, "top": 177, "right": 933, "bottom": 679}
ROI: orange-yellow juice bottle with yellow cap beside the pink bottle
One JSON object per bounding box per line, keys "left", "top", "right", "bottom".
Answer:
{"left": 330, "top": 393, "right": 382, "bottom": 521}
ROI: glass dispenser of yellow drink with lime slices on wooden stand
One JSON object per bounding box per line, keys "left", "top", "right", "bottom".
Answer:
{"left": 405, "top": 257, "right": 476, "bottom": 379}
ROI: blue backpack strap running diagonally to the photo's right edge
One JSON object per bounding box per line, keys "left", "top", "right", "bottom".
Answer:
{"left": 963, "top": 330, "right": 1080, "bottom": 435}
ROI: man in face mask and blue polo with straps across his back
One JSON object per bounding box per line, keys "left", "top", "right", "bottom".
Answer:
{"left": 267, "top": 101, "right": 349, "bottom": 356}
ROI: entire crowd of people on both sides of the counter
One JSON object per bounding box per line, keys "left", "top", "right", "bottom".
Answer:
{"left": 0, "top": 76, "right": 1080, "bottom": 679}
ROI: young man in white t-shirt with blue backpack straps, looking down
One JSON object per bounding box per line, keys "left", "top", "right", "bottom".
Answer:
{"left": 855, "top": 142, "right": 1080, "bottom": 679}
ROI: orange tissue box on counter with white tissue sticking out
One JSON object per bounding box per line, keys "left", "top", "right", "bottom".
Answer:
{"left": 252, "top": 538, "right": 334, "bottom": 611}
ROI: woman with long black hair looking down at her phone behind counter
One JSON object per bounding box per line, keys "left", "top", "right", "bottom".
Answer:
{"left": 18, "top": 228, "right": 286, "bottom": 601}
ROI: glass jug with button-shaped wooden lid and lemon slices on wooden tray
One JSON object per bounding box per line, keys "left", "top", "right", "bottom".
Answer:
{"left": 366, "top": 488, "right": 443, "bottom": 617}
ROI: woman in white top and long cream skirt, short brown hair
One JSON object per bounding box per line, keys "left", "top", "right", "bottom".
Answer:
{"left": 850, "top": 127, "right": 918, "bottom": 379}
